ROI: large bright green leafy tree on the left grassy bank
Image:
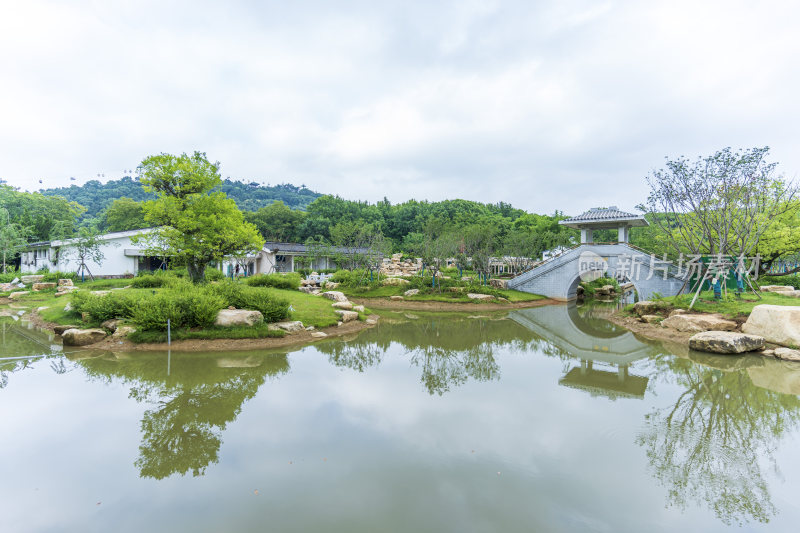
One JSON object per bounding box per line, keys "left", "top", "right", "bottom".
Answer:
{"left": 140, "top": 152, "right": 264, "bottom": 283}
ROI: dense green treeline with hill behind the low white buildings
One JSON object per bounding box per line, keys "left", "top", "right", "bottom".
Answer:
{"left": 6, "top": 177, "right": 577, "bottom": 257}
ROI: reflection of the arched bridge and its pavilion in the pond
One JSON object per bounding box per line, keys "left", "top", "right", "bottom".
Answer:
{"left": 508, "top": 304, "right": 653, "bottom": 399}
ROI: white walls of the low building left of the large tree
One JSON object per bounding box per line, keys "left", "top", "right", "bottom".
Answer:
{"left": 20, "top": 228, "right": 162, "bottom": 277}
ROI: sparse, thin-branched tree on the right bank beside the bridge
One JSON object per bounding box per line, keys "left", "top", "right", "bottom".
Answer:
{"left": 639, "top": 147, "right": 797, "bottom": 256}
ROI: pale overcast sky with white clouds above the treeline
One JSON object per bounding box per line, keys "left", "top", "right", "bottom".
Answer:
{"left": 0, "top": 0, "right": 800, "bottom": 213}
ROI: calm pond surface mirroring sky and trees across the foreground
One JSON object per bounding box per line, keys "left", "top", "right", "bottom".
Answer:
{"left": 0, "top": 306, "right": 800, "bottom": 532}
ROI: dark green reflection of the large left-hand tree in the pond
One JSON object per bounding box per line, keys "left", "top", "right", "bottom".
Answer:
{"left": 79, "top": 354, "right": 289, "bottom": 479}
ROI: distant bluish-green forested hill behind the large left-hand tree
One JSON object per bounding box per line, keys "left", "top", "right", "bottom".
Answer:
{"left": 41, "top": 177, "right": 321, "bottom": 215}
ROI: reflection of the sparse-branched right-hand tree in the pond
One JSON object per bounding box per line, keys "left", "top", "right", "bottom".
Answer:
{"left": 637, "top": 355, "right": 800, "bottom": 524}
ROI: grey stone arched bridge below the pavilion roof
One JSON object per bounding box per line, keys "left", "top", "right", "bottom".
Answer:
{"left": 508, "top": 242, "right": 684, "bottom": 301}
